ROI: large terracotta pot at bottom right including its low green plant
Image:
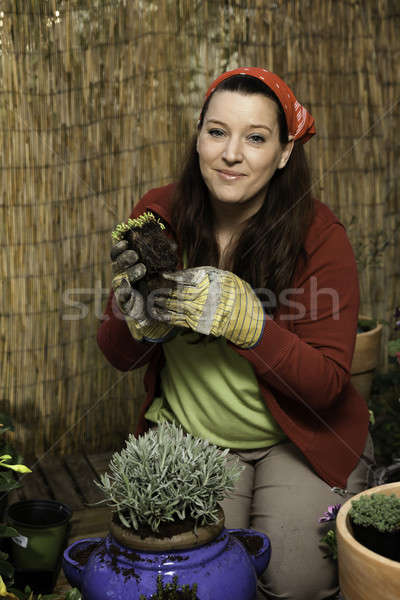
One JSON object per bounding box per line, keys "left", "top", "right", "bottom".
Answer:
{"left": 336, "top": 482, "right": 400, "bottom": 600}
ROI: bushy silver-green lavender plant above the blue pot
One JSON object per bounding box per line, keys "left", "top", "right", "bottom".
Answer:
{"left": 97, "top": 423, "right": 242, "bottom": 531}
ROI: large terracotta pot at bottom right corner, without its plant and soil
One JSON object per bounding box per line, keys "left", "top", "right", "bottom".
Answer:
{"left": 336, "top": 482, "right": 400, "bottom": 600}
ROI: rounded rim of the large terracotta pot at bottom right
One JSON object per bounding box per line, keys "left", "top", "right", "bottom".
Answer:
{"left": 336, "top": 481, "right": 400, "bottom": 575}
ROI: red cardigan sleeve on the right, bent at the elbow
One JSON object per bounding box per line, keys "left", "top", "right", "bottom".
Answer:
{"left": 232, "top": 222, "right": 359, "bottom": 411}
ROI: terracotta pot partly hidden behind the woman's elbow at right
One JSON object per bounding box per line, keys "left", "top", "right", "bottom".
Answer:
{"left": 351, "top": 316, "right": 382, "bottom": 401}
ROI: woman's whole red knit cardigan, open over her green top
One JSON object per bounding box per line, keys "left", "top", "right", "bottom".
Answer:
{"left": 97, "top": 185, "right": 369, "bottom": 488}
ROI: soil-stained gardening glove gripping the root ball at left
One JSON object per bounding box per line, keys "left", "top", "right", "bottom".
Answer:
{"left": 111, "top": 240, "right": 174, "bottom": 342}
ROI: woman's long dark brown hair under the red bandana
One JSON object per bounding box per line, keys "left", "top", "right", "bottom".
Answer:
{"left": 172, "top": 75, "right": 314, "bottom": 312}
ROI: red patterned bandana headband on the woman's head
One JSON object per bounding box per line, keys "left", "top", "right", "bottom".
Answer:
{"left": 204, "top": 67, "right": 315, "bottom": 144}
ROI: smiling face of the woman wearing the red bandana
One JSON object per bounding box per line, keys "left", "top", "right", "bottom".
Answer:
{"left": 197, "top": 91, "right": 293, "bottom": 212}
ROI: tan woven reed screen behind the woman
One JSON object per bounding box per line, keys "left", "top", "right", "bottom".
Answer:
{"left": 0, "top": 0, "right": 400, "bottom": 452}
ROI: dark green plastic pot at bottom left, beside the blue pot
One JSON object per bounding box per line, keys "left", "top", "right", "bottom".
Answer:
{"left": 6, "top": 500, "right": 72, "bottom": 593}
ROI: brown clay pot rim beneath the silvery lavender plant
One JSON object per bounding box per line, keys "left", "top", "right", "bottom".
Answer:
{"left": 110, "top": 508, "right": 225, "bottom": 552}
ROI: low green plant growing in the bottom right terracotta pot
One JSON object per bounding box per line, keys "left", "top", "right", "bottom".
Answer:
{"left": 349, "top": 494, "right": 400, "bottom": 532}
